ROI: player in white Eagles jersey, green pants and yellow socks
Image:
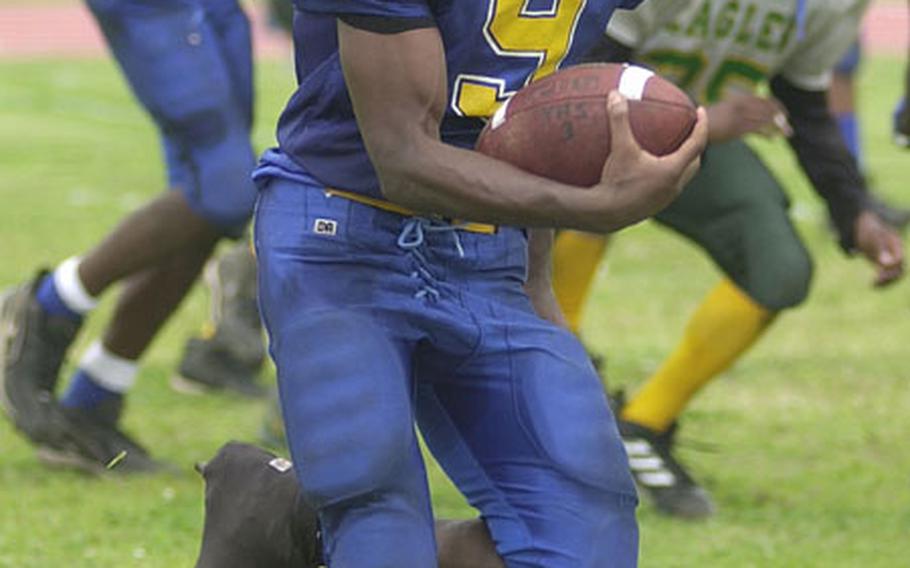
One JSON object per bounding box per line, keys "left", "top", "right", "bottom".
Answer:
{"left": 554, "top": 0, "right": 903, "bottom": 518}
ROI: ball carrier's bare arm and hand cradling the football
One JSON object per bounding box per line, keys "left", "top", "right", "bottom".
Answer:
{"left": 338, "top": 22, "right": 707, "bottom": 232}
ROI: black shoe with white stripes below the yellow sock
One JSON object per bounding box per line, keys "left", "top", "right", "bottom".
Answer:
{"left": 616, "top": 418, "right": 714, "bottom": 519}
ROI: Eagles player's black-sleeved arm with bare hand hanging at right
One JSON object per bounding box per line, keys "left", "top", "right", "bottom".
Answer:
{"left": 771, "top": 76, "right": 904, "bottom": 286}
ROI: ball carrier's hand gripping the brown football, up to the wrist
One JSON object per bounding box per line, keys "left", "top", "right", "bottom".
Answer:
{"left": 593, "top": 91, "right": 708, "bottom": 229}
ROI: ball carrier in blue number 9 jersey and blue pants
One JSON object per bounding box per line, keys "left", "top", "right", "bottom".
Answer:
{"left": 254, "top": 0, "right": 706, "bottom": 568}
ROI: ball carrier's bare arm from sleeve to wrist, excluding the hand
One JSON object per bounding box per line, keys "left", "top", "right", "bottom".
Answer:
{"left": 338, "top": 22, "right": 622, "bottom": 229}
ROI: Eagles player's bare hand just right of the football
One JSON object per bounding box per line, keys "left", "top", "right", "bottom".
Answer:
{"left": 707, "top": 94, "right": 793, "bottom": 142}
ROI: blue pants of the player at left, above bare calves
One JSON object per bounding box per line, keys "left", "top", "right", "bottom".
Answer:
{"left": 86, "top": 0, "right": 256, "bottom": 236}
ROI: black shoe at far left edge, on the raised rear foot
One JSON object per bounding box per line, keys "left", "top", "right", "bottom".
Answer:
{"left": 0, "top": 272, "right": 80, "bottom": 444}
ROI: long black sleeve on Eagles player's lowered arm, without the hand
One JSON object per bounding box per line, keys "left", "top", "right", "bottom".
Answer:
{"left": 771, "top": 77, "right": 868, "bottom": 250}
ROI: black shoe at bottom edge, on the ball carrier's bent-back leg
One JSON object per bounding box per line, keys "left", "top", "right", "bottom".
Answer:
{"left": 196, "top": 442, "right": 323, "bottom": 568}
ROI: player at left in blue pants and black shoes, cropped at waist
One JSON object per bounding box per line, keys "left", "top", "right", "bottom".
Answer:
{"left": 0, "top": 0, "right": 255, "bottom": 472}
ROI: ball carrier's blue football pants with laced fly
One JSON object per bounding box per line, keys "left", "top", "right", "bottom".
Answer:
{"left": 255, "top": 177, "right": 638, "bottom": 568}
